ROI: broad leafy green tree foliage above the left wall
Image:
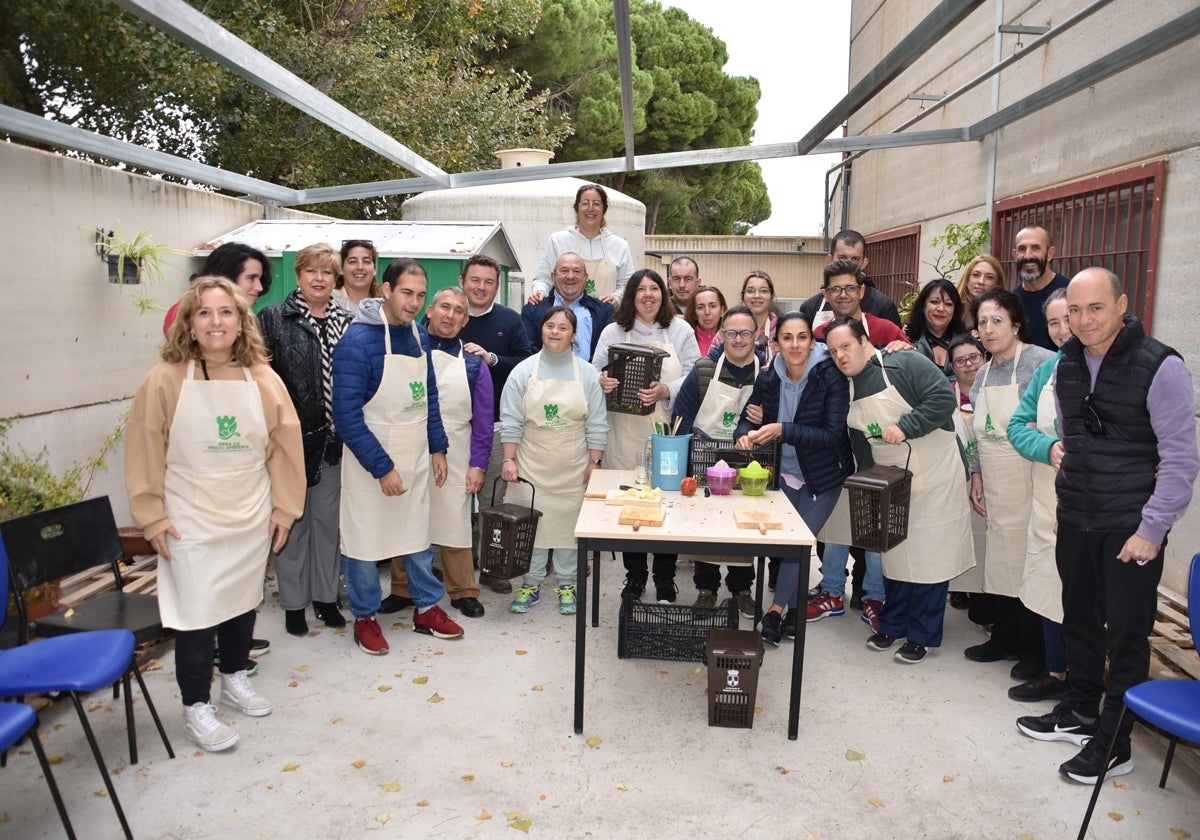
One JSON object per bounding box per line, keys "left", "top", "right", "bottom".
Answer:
{"left": 0, "top": 0, "right": 569, "bottom": 217}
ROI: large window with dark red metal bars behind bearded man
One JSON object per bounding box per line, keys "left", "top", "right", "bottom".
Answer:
{"left": 993, "top": 161, "right": 1166, "bottom": 332}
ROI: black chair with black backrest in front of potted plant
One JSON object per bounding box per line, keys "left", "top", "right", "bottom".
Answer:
{"left": 0, "top": 496, "right": 175, "bottom": 764}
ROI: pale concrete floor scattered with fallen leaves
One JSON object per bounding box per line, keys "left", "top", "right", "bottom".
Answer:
{"left": 0, "top": 559, "right": 1200, "bottom": 840}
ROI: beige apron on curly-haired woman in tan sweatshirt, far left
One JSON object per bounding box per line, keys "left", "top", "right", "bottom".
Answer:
{"left": 158, "top": 361, "right": 271, "bottom": 630}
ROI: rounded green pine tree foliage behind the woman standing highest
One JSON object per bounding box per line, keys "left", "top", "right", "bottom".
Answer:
{"left": 499, "top": 0, "right": 770, "bottom": 234}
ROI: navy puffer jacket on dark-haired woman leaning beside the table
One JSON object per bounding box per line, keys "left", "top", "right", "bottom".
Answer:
{"left": 733, "top": 359, "right": 854, "bottom": 496}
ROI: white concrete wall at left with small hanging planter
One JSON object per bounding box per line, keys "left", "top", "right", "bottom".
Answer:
{"left": 0, "top": 143, "right": 324, "bottom": 523}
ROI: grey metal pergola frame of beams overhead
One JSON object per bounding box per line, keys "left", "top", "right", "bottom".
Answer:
{"left": 0, "top": 0, "right": 1200, "bottom": 206}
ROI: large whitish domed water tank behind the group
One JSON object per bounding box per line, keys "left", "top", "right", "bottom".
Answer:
{"left": 403, "top": 149, "right": 661, "bottom": 298}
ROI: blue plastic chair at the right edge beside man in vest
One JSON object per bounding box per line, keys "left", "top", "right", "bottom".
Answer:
{"left": 1079, "top": 553, "right": 1200, "bottom": 840}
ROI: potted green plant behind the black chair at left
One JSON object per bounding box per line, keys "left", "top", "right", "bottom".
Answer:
{"left": 0, "top": 414, "right": 128, "bottom": 620}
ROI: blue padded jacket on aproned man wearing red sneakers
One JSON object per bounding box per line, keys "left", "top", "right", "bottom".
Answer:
{"left": 334, "top": 300, "right": 450, "bottom": 479}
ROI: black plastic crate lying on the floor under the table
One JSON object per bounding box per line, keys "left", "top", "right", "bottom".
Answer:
{"left": 617, "top": 598, "right": 738, "bottom": 662}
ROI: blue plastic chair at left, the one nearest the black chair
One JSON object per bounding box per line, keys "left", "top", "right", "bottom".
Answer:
{"left": 0, "top": 540, "right": 133, "bottom": 840}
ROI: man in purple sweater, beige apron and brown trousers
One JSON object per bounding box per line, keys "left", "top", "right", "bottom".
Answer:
{"left": 380, "top": 286, "right": 493, "bottom": 618}
